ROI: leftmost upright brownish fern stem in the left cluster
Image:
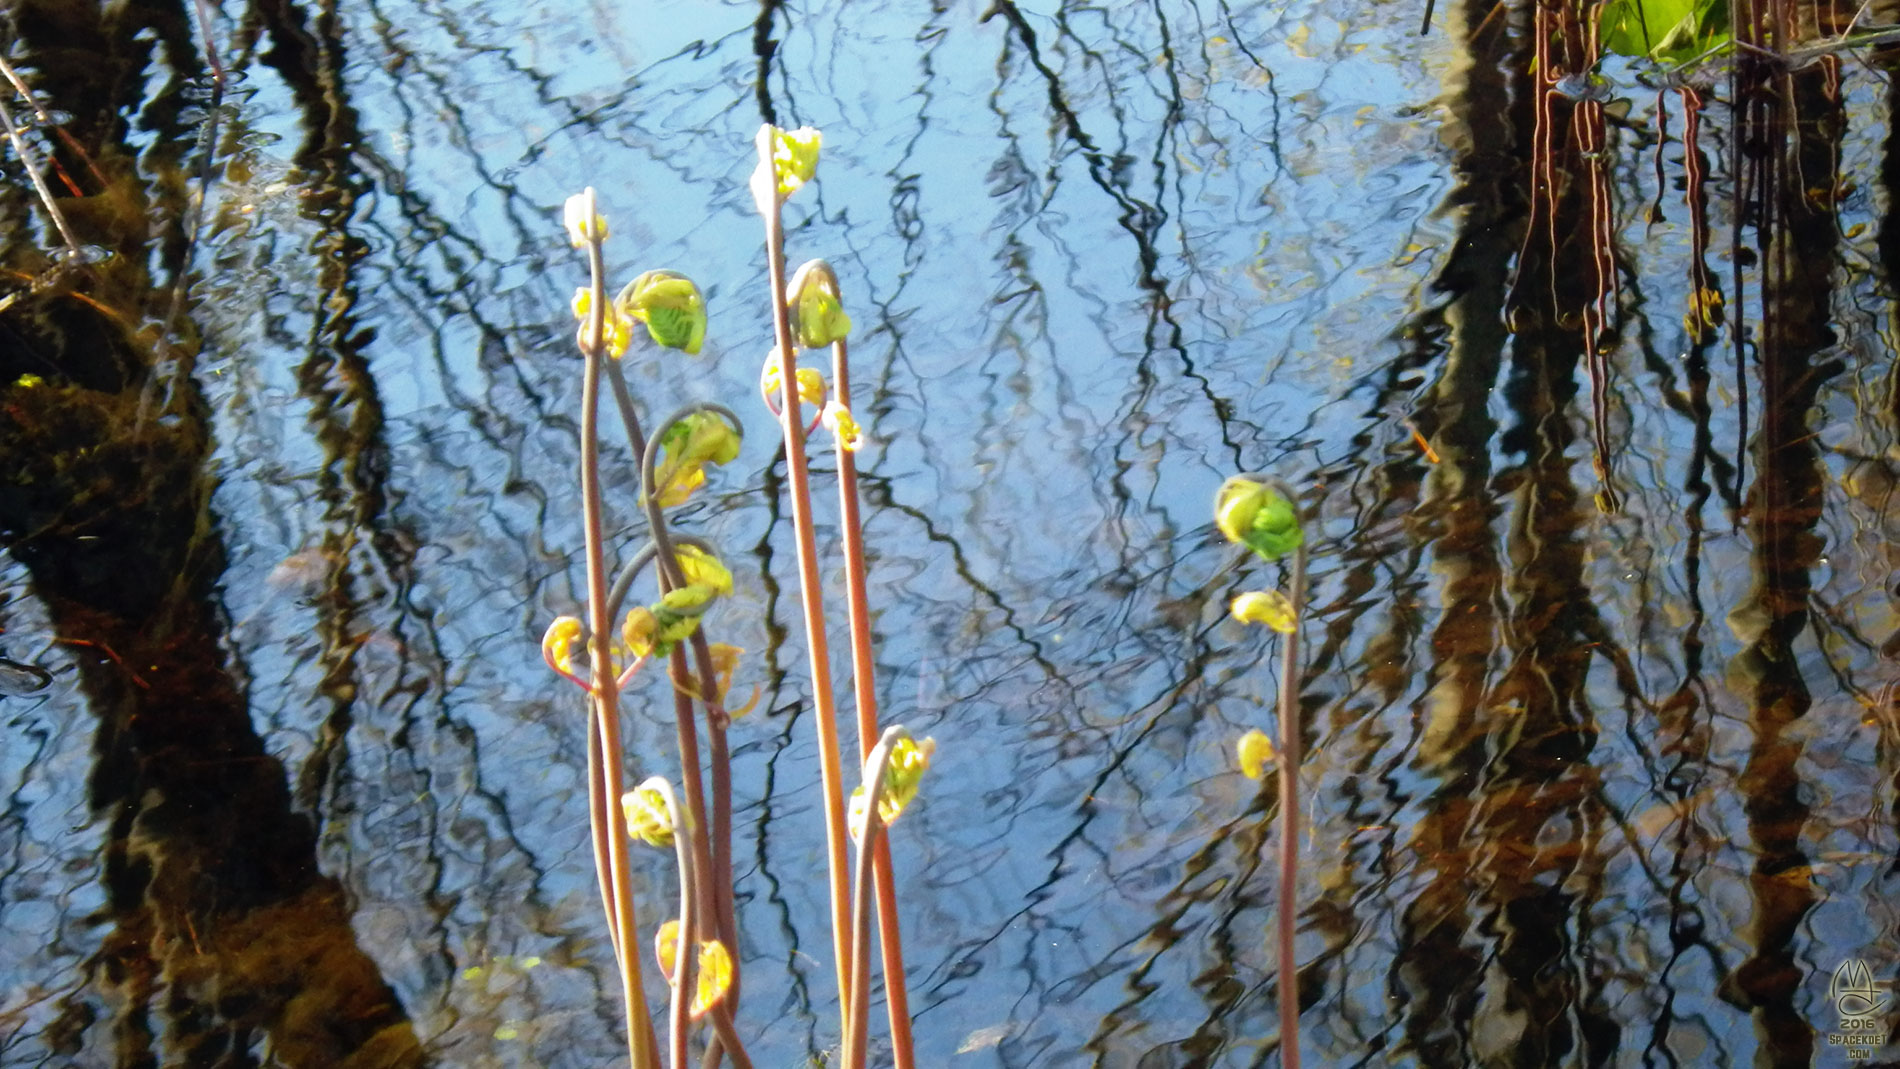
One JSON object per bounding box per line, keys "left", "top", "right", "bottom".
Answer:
{"left": 581, "top": 213, "right": 659, "bottom": 1069}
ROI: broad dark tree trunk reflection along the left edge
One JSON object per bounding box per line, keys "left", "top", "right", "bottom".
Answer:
{"left": 0, "top": 4, "right": 422, "bottom": 1069}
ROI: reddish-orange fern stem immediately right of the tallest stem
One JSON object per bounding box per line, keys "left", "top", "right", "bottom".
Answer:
{"left": 827, "top": 336, "right": 916, "bottom": 1069}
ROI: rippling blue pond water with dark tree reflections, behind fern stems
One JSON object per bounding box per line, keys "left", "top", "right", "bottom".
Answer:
{"left": 0, "top": 0, "right": 1900, "bottom": 1069}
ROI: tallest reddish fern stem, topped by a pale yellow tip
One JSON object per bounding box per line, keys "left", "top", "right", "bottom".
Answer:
{"left": 754, "top": 125, "right": 855, "bottom": 1027}
